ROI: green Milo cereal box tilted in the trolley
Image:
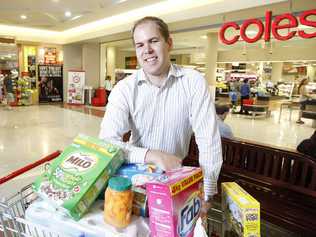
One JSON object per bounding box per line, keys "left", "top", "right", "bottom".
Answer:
{"left": 33, "top": 135, "right": 124, "bottom": 220}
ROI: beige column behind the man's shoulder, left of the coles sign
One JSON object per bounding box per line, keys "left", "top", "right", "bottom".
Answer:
{"left": 205, "top": 32, "right": 218, "bottom": 99}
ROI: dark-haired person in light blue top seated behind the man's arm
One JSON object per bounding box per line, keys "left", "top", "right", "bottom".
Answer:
{"left": 215, "top": 105, "right": 234, "bottom": 139}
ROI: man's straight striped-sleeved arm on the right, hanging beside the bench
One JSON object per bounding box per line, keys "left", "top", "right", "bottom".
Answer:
{"left": 191, "top": 73, "right": 223, "bottom": 200}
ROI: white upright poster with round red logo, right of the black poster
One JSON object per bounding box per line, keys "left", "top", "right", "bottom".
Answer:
{"left": 67, "top": 71, "right": 85, "bottom": 104}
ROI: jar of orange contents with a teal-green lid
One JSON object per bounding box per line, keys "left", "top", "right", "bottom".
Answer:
{"left": 104, "top": 177, "right": 133, "bottom": 228}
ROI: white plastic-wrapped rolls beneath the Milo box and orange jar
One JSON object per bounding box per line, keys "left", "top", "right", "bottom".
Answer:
{"left": 25, "top": 199, "right": 150, "bottom": 237}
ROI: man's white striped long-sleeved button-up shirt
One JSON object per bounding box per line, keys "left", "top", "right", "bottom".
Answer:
{"left": 99, "top": 65, "right": 222, "bottom": 197}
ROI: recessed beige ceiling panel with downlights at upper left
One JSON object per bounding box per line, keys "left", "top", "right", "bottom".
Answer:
{"left": 0, "top": 0, "right": 161, "bottom": 31}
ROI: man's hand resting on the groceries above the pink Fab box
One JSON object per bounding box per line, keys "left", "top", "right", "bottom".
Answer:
{"left": 145, "top": 150, "right": 182, "bottom": 171}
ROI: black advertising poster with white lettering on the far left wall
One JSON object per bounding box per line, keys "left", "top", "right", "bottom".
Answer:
{"left": 38, "top": 65, "right": 63, "bottom": 103}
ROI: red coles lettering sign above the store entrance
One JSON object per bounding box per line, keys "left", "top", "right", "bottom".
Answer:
{"left": 219, "top": 9, "right": 316, "bottom": 44}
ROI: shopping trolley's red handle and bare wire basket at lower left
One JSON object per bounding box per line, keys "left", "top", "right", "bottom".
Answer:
{"left": 0, "top": 151, "right": 62, "bottom": 237}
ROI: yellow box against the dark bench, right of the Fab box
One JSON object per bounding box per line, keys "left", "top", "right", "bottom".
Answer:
{"left": 222, "top": 182, "right": 260, "bottom": 237}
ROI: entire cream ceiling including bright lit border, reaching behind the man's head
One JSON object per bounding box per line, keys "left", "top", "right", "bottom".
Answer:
{"left": 0, "top": 0, "right": 288, "bottom": 44}
